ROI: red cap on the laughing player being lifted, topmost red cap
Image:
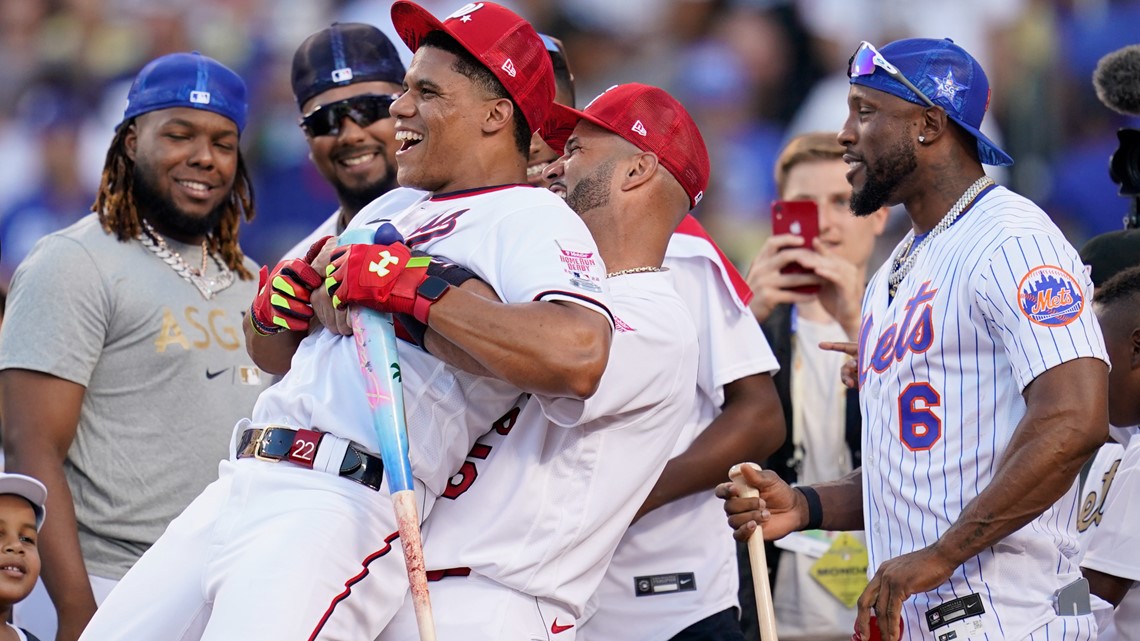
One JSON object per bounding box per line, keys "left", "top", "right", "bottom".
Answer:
{"left": 392, "top": 0, "right": 554, "bottom": 131}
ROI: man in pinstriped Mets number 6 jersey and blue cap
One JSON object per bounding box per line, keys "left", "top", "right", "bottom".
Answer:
{"left": 718, "top": 40, "right": 1108, "bottom": 641}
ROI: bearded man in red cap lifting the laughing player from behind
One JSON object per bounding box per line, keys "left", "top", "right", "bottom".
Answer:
{"left": 381, "top": 84, "right": 709, "bottom": 641}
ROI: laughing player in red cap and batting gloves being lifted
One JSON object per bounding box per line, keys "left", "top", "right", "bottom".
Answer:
{"left": 84, "top": 1, "right": 612, "bottom": 641}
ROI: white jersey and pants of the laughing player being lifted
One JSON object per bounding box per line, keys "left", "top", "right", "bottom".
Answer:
{"left": 83, "top": 186, "right": 610, "bottom": 641}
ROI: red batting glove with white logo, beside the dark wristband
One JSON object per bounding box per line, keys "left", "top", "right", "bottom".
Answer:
{"left": 325, "top": 243, "right": 431, "bottom": 314}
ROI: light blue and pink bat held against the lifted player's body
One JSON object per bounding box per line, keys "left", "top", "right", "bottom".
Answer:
{"left": 337, "top": 229, "right": 435, "bottom": 641}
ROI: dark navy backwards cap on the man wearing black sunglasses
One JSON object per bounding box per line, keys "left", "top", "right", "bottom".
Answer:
{"left": 293, "top": 23, "right": 405, "bottom": 108}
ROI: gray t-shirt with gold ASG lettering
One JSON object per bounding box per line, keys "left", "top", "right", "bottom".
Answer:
{"left": 0, "top": 214, "right": 269, "bottom": 579}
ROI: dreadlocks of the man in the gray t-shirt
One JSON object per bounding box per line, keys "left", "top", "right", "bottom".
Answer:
{"left": 91, "top": 119, "right": 253, "bottom": 281}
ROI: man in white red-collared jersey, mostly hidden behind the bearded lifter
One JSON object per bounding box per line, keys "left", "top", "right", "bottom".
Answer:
{"left": 527, "top": 45, "right": 784, "bottom": 641}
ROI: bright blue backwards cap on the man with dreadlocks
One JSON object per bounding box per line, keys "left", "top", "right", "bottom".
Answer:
{"left": 116, "top": 51, "right": 249, "bottom": 133}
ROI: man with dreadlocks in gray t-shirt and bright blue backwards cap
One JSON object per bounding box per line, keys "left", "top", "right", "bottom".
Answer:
{"left": 0, "top": 52, "right": 269, "bottom": 640}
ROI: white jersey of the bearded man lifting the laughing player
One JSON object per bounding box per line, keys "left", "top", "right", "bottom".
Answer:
{"left": 424, "top": 271, "right": 698, "bottom": 626}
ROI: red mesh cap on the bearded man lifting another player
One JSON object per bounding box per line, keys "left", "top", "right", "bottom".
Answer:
{"left": 540, "top": 82, "right": 709, "bottom": 209}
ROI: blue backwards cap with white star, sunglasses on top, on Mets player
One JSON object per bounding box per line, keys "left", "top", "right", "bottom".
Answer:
{"left": 849, "top": 38, "right": 1013, "bottom": 165}
